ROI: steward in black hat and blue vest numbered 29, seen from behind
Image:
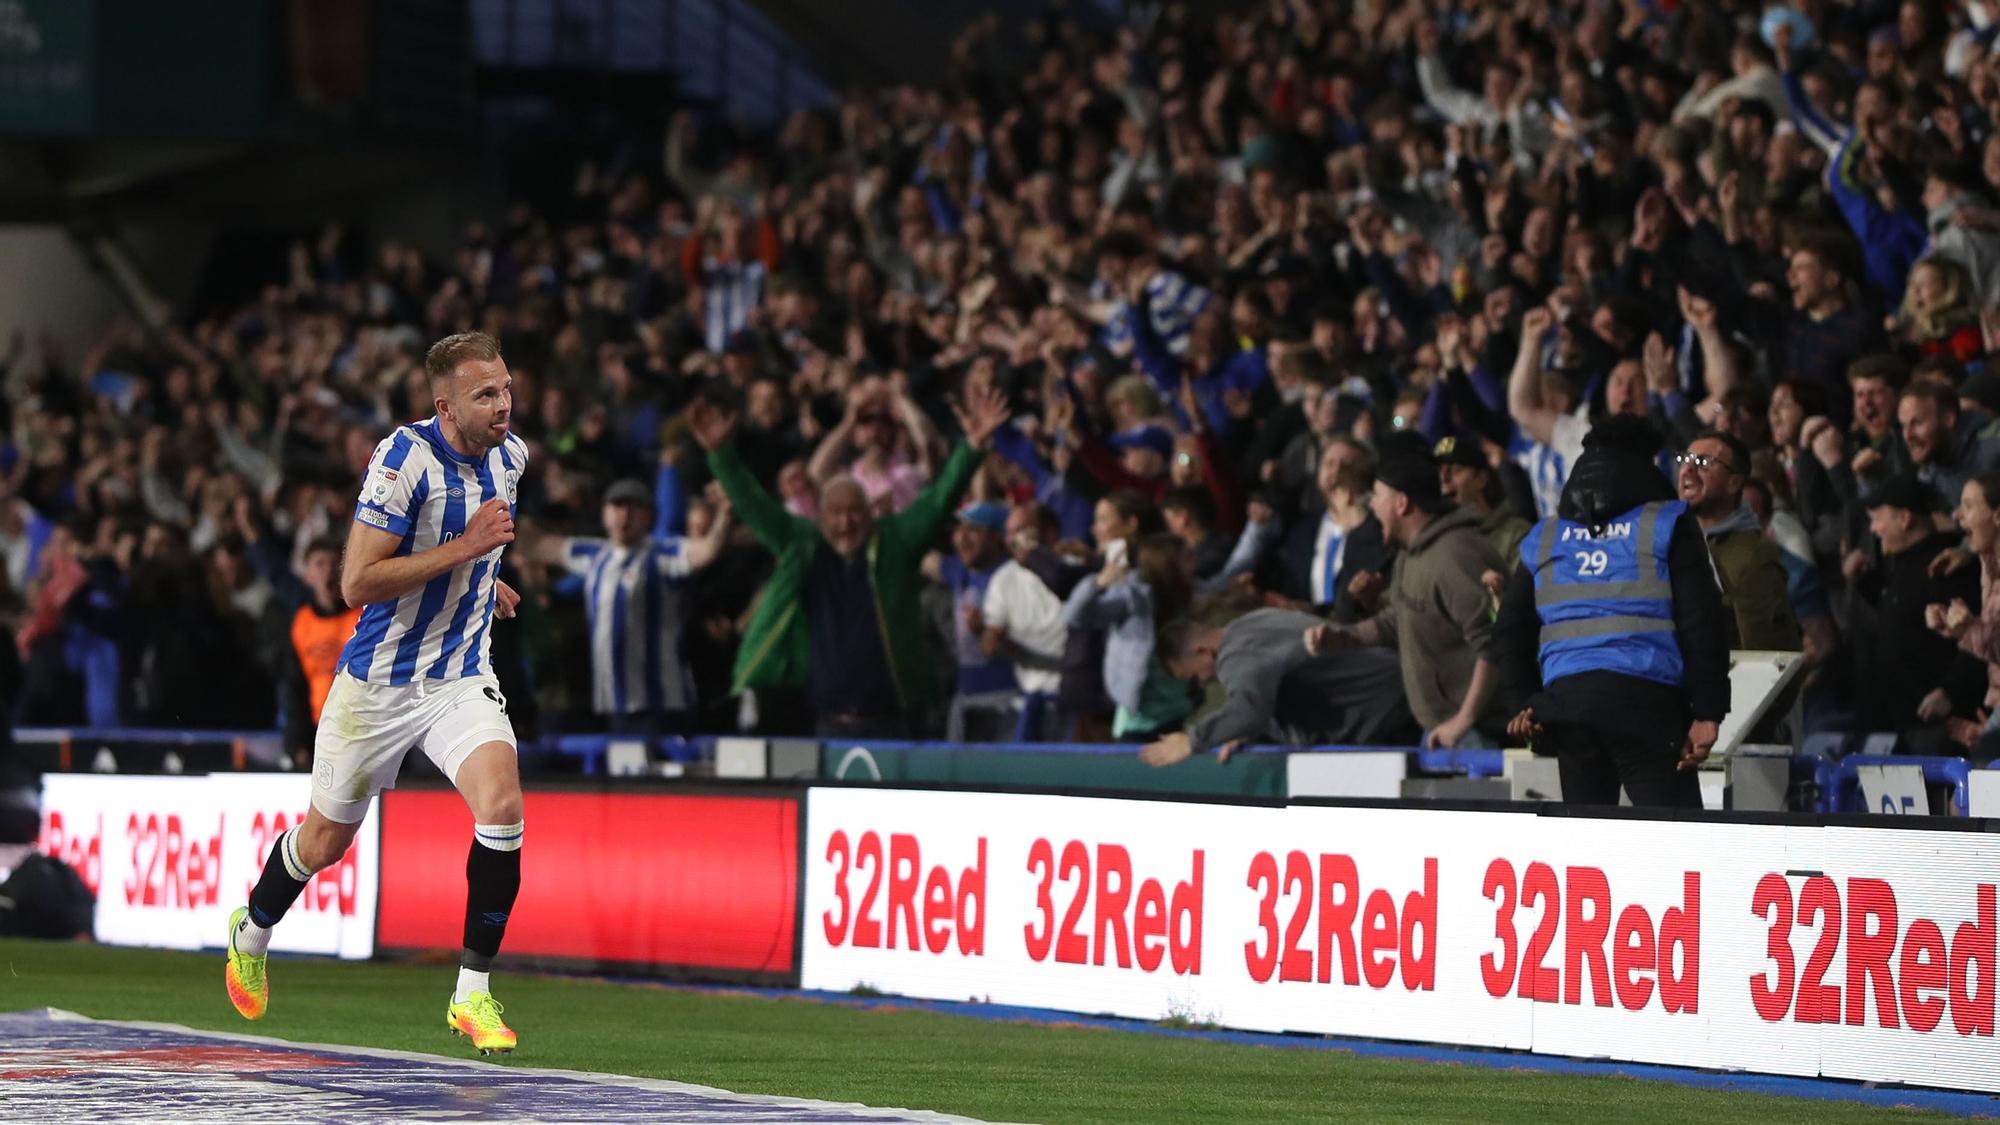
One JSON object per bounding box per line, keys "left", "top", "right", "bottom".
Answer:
{"left": 1488, "top": 418, "right": 1730, "bottom": 809}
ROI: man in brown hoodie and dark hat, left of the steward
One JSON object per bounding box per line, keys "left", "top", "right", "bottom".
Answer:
{"left": 1306, "top": 440, "right": 1504, "bottom": 747}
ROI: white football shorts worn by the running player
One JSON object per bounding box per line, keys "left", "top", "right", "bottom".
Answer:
{"left": 312, "top": 671, "right": 516, "bottom": 825}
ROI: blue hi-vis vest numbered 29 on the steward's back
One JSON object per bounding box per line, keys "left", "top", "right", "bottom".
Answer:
{"left": 1520, "top": 500, "right": 1688, "bottom": 687}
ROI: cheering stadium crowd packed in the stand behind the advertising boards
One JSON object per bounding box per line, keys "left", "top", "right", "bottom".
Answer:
{"left": 0, "top": 0, "right": 2000, "bottom": 761}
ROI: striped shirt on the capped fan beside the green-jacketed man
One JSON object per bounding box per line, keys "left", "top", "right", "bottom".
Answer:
{"left": 562, "top": 534, "right": 694, "bottom": 715}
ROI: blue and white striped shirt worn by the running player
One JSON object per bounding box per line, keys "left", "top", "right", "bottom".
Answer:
{"left": 340, "top": 418, "right": 528, "bottom": 685}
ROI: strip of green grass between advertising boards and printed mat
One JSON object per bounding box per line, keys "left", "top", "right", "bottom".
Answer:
{"left": 0, "top": 941, "right": 1954, "bottom": 1125}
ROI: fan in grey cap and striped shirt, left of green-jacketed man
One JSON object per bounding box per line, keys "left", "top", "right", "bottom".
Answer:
{"left": 528, "top": 466, "right": 730, "bottom": 737}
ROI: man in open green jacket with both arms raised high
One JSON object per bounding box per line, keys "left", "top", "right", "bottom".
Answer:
{"left": 688, "top": 388, "right": 1008, "bottom": 739}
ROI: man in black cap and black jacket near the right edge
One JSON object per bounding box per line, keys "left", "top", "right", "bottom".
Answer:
{"left": 1850, "top": 472, "right": 1986, "bottom": 753}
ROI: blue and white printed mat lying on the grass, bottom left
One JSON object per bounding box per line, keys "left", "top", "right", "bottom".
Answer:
{"left": 0, "top": 1009, "right": 996, "bottom": 1125}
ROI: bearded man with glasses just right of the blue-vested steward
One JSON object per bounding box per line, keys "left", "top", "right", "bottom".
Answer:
{"left": 1674, "top": 432, "right": 1800, "bottom": 653}
